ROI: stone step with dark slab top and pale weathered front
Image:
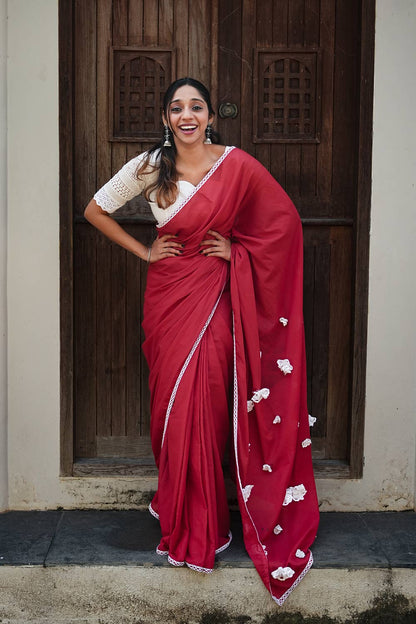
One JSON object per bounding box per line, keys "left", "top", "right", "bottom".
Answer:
{"left": 0, "top": 510, "right": 416, "bottom": 624}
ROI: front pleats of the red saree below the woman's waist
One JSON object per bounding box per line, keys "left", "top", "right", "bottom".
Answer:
{"left": 152, "top": 293, "right": 232, "bottom": 571}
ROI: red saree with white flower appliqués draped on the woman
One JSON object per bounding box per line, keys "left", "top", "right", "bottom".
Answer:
{"left": 143, "top": 148, "right": 318, "bottom": 604}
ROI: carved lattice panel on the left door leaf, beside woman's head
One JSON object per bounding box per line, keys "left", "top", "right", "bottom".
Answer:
{"left": 110, "top": 47, "right": 173, "bottom": 141}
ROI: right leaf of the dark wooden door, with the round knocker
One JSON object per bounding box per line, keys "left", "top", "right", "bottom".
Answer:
{"left": 218, "top": 0, "right": 361, "bottom": 472}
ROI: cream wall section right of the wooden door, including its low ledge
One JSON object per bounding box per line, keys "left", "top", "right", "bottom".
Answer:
{"left": 319, "top": 0, "right": 416, "bottom": 510}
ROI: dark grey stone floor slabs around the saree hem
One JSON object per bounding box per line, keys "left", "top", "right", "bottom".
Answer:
{"left": 0, "top": 510, "right": 416, "bottom": 568}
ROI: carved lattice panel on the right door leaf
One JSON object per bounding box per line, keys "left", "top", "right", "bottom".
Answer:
{"left": 253, "top": 50, "right": 321, "bottom": 143}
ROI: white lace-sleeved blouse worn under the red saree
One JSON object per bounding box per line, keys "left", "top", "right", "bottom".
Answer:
{"left": 94, "top": 146, "right": 232, "bottom": 225}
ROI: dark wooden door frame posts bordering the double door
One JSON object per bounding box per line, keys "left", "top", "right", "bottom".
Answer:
{"left": 59, "top": 0, "right": 375, "bottom": 479}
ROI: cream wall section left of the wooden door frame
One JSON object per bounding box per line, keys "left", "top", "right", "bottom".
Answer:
{"left": 7, "top": 0, "right": 59, "bottom": 508}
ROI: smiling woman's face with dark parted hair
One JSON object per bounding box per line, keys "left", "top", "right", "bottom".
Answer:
{"left": 163, "top": 85, "right": 212, "bottom": 146}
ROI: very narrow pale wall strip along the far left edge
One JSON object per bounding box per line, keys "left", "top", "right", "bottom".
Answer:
{"left": 0, "top": 0, "right": 8, "bottom": 511}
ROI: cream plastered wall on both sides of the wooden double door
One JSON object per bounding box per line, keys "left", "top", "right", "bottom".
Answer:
{"left": 0, "top": 0, "right": 416, "bottom": 510}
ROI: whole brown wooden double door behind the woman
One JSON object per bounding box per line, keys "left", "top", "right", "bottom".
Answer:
{"left": 61, "top": 0, "right": 374, "bottom": 476}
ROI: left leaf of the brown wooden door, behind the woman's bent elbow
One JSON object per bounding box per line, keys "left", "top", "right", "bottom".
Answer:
{"left": 66, "top": 0, "right": 218, "bottom": 474}
